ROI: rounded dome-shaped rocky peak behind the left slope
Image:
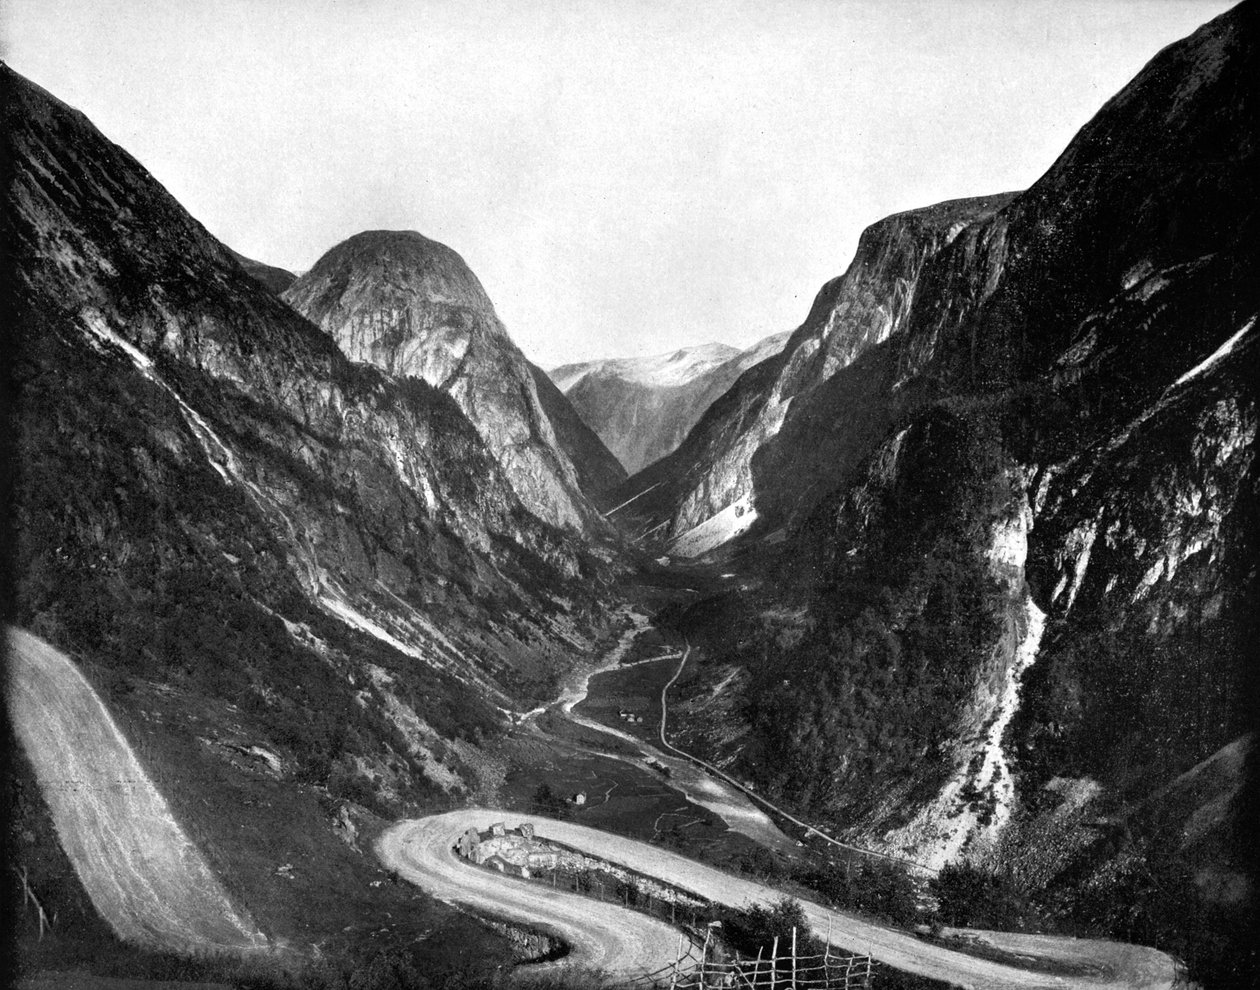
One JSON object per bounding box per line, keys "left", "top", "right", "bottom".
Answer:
{"left": 284, "top": 230, "right": 624, "bottom": 529}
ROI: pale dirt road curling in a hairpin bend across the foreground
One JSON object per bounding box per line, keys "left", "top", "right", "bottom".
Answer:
{"left": 377, "top": 807, "right": 1177, "bottom": 990}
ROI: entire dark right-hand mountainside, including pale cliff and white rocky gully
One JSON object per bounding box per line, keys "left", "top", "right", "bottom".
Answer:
{"left": 635, "top": 3, "right": 1260, "bottom": 985}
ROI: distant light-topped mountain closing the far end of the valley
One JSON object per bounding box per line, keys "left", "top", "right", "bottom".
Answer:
{"left": 551, "top": 334, "right": 788, "bottom": 471}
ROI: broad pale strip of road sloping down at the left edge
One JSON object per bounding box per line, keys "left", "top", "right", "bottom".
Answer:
{"left": 8, "top": 629, "right": 271, "bottom": 952}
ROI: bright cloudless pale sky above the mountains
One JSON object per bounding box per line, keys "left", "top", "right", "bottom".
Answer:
{"left": 0, "top": 0, "right": 1232, "bottom": 367}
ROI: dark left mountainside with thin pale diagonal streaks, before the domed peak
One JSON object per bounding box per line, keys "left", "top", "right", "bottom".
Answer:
{"left": 0, "top": 59, "right": 619, "bottom": 941}
